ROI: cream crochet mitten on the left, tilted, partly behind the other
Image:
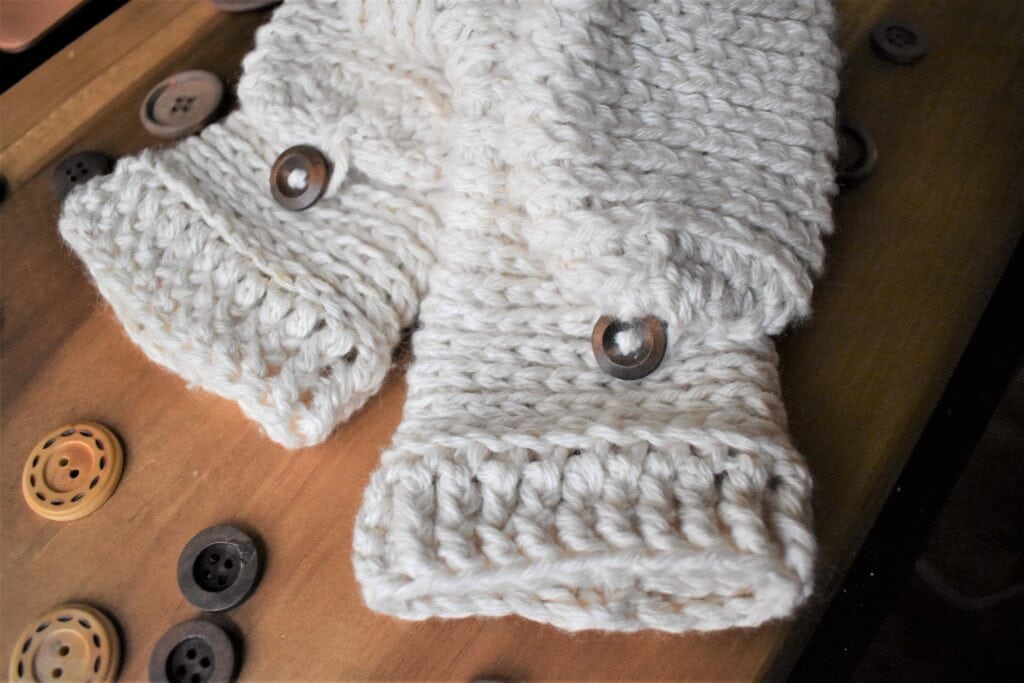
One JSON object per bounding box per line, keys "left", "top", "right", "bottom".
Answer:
{"left": 60, "top": 0, "right": 449, "bottom": 447}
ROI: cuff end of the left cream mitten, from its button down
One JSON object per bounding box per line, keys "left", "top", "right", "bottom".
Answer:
{"left": 60, "top": 113, "right": 437, "bottom": 447}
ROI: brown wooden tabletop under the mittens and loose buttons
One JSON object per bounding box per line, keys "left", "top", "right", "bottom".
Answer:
{"left": 0, "top": 0, "right": 1024, "bottom": 680}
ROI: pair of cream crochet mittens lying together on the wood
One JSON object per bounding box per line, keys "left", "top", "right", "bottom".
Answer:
{"left": 61, "top": 0, "right": 838, "bottom": 632}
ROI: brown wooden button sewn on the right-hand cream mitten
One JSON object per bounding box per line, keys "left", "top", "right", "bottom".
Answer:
{"left": 591, "top": 315, "right": 666, "bottom": 380}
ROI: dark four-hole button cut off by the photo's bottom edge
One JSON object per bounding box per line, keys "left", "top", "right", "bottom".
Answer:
{"left": 150, "top": 620, "right": 236, "bottom": 683}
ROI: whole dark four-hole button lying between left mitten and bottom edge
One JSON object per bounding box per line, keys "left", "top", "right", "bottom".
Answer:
{"left": 178, "top": 525, "right": 259, "bottom": 611}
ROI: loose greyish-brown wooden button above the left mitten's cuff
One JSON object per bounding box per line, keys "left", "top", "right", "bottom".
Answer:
{"left": 139, "top": 71, "right": 224, "bottom": 138}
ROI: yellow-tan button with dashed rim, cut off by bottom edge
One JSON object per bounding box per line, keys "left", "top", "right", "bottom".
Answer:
{"left": 9, "top": 604, "right": 121, "bottom": 681}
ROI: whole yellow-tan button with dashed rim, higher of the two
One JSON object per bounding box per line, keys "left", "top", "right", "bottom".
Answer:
{"left": 22, "top": 422, "right": 124, "bottom": 521}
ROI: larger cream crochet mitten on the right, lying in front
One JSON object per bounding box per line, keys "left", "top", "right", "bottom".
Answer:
{"left": 354, "top": 0, "right": 838, "bottom": 632}
